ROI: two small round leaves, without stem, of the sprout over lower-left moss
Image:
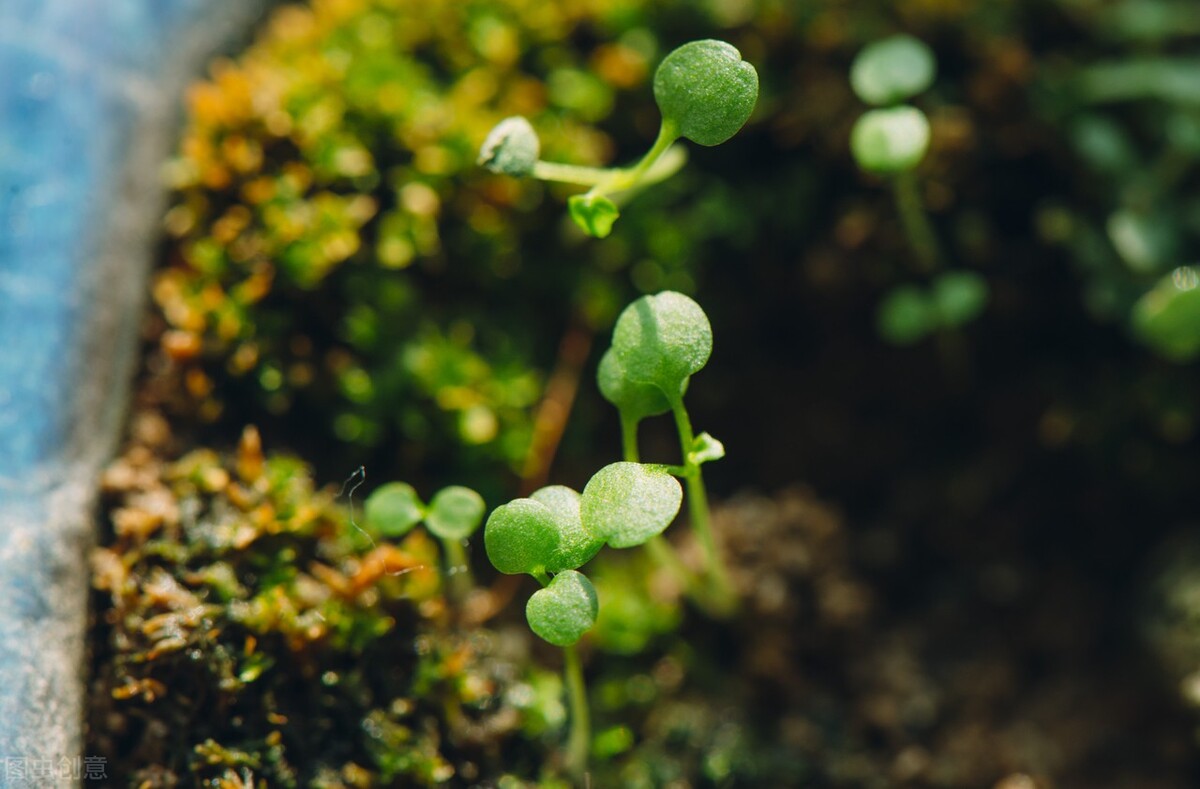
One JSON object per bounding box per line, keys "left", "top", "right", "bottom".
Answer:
{"left": 365, "top": 482, "right": 487, "bottom": 540}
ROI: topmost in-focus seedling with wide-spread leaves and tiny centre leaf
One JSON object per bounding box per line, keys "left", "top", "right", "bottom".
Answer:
{"left": 479, "top": 40, "right": 758, "bottom": 239}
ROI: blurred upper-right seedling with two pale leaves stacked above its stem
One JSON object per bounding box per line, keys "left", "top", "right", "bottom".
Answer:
{"left": 850, "top": 35, "right": 941, "bottom": 272}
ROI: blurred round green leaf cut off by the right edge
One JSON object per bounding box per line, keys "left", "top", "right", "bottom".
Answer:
{"left": 1132, "top": 267, "right": 1200, "bottom": 362}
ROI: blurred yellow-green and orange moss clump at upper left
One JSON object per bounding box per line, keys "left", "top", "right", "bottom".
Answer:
{"left": 152, "top": 0, "right": 644, "bottom": 479}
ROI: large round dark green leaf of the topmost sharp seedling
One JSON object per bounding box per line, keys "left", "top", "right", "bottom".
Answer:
{"left": 654, "top": 38, "right": 758, "bottom": 145}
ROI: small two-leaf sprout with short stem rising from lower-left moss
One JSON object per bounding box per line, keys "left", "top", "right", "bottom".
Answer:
{"left": 364, "top": 482, "right": 487, "bottom": 600}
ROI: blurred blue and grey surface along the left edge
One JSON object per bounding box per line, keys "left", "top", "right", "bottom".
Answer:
{"left": 0, "top": 0, "right": 265, "bottom": 788}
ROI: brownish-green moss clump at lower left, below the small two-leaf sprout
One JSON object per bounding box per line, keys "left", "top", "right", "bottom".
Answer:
{"left": 88, "top": 430, "right": 556, "bottom": 787}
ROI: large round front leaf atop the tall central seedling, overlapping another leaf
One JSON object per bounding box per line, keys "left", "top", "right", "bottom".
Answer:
{"left": 612, "top": 290, "right": 713, "bottom": 402}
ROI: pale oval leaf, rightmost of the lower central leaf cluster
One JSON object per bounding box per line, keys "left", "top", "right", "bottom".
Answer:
{"left": 580, "top": 463, "right": 683, "bottom": 548}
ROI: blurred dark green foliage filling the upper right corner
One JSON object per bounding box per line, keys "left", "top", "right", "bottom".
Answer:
{"left": 1034, "top": 0, "right": 1200, "bottom": 362}
